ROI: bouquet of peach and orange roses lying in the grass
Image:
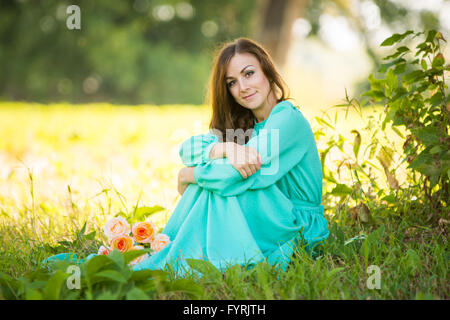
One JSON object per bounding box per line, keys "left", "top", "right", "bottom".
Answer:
{"left": 98, "top": 217, "right": 170, "bottom": 266}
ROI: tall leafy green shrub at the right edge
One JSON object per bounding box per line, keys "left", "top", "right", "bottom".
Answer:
{"left": 364, "top": 30, "right": 450, "bottom": 212}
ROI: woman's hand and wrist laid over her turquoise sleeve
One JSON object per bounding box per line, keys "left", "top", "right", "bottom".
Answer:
{"left": 225, "top": 142, "right": 262, "bottom": 179}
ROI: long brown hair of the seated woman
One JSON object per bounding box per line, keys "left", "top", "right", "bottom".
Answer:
{"left": 207, "top": 38, "right": 290, "bottom": 143}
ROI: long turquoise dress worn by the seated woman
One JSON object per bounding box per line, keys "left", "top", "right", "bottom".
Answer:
{"left": 133, "top": 101, "right": 329, "bottom": 273}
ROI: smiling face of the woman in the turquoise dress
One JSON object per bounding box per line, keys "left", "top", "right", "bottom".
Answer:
{"left": 225, "top": 53, "right": 270, "bottom": 110}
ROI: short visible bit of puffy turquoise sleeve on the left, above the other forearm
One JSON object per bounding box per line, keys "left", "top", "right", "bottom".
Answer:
{"left": 179, "top": 132, "right": 219, "bottom": 167}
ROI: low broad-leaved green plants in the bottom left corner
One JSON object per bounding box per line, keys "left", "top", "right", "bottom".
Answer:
{"left": 0, "top": 250, "right": 203, "bottom": 300}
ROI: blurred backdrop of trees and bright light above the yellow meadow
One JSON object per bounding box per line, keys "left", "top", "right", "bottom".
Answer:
{"left": 0, "top": 0, "right": 450, "bottom": 108}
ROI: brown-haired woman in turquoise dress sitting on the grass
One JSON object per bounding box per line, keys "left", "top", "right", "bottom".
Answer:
{"left": 134, "top": 38, "right": 329, "bottom": 272}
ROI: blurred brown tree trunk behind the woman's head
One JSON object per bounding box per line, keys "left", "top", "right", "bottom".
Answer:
{"left": 254, "top": 0, "right": 310, "bottom": 68}
